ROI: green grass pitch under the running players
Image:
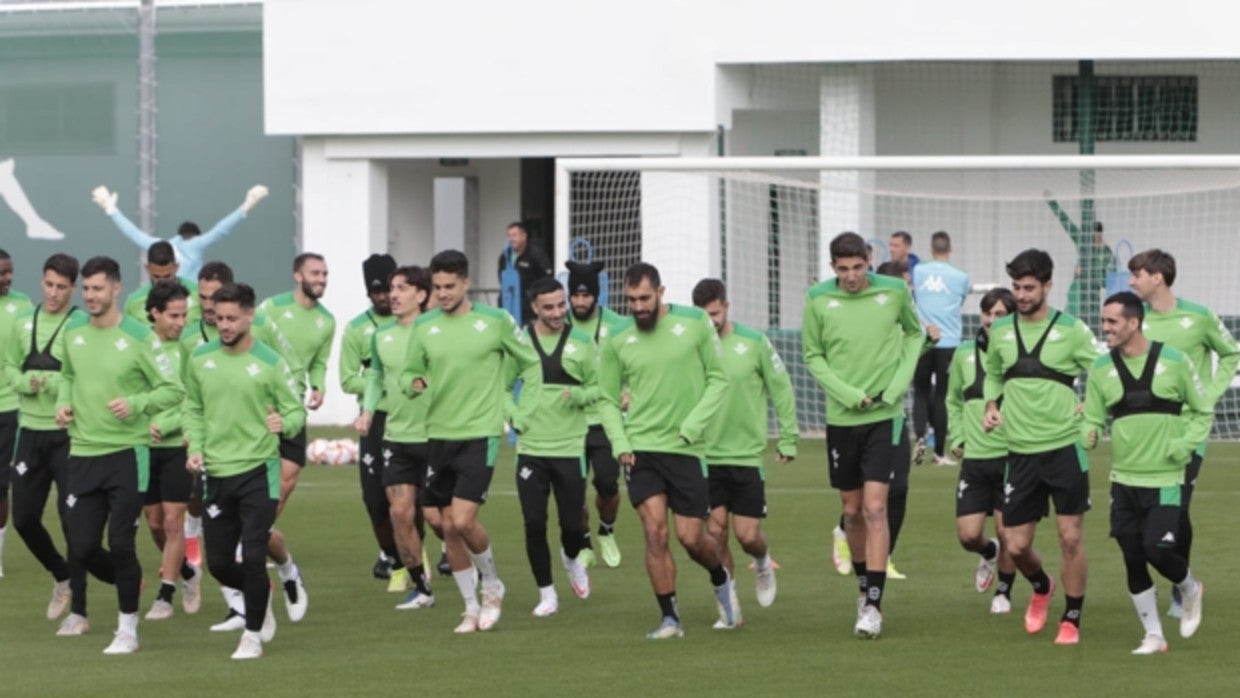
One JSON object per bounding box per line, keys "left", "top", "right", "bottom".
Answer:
{"left": 0, "top": 441, "right": 1240, "bottom": 698}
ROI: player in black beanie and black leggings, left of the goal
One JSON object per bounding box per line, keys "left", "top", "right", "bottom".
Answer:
{"left": 340, "top": 254, "right": 396, "bottom": 591}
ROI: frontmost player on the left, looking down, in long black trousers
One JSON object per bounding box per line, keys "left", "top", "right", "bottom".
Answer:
{"left": 185, "top": 284, "right": 305, "bottom": 660}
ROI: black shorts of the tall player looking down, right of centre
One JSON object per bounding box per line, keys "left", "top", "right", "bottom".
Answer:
{"left": 827, "top": 417, "right": 910, "bottom": 492}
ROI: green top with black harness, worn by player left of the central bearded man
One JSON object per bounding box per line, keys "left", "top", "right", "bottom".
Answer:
{"left": 505, "top": 326, "right": 601, "bottom": 457}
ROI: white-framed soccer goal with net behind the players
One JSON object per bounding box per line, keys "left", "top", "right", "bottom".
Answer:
{"left": 556, "top": 156, "right": 1240, "bottom": 439}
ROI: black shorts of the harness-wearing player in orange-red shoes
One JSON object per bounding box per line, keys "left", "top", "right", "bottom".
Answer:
{"left": 1003, "top": 444, "right": 1090, "bottom": 526}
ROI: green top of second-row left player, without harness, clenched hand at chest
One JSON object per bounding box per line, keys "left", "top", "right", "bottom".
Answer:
{"left": 56, "top": 314, "right": 185, "bottom": 456}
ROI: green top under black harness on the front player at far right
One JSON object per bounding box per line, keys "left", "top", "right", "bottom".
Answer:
{"left": 1081, "top": 346, "right": 1214, "bottom": 487}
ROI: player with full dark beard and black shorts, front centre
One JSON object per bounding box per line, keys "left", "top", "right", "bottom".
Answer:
{"left": 599, "top": 262, "right": 742, "bottom": 640}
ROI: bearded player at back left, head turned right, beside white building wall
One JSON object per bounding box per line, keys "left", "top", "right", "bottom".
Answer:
{"left": 258, "top": 252, "right": 336, "bottom": 622}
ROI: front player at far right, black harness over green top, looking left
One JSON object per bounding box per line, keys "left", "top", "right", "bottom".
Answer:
{"left": 1081, "top": 291, "right": 1214, "bottom": 655}
